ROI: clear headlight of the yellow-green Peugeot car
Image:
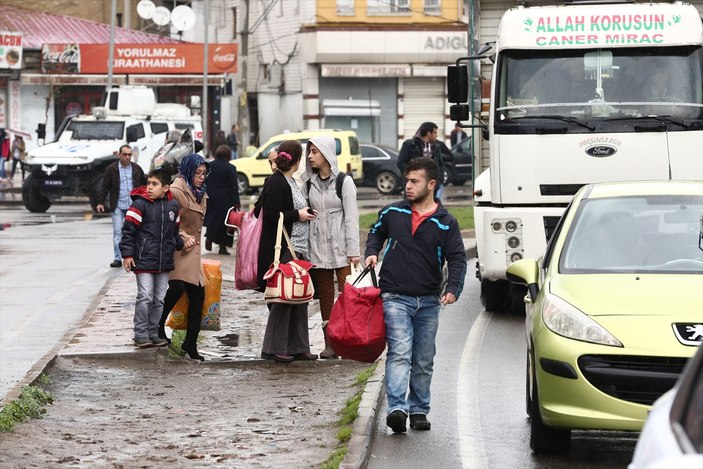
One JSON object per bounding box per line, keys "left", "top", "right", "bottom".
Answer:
{"left": 542, "top": 293, "right": 622, "bottom": 347}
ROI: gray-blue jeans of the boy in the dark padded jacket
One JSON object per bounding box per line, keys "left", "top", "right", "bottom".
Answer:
{"left": 134, "top": 272, "right": 168, "bottom": 339}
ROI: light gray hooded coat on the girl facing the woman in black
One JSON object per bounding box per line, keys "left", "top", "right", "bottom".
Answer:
{"left": 301, "top": 135, "right": 359, "bottom": 269}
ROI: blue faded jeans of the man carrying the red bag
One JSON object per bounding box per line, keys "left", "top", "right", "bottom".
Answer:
{"left": 382, "top": 293, "right": 440, "bottom": 415}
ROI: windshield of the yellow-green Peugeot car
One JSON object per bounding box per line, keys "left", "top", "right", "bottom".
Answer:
{"left": 559, "top": 195, "right": 703, "bottom": 274}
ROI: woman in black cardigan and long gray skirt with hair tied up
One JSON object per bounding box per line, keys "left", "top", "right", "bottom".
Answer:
{"left": 254, "top": 140, "right": 317, "bottom": 363}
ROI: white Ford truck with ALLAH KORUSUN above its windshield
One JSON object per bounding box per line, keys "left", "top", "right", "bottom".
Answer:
{"left": 448, "top": 0, "right": 703, "bottom": 311}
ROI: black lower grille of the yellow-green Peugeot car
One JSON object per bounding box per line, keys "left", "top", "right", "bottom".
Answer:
{"left": 578, "top": 355, "right": 687, "bottom": 405}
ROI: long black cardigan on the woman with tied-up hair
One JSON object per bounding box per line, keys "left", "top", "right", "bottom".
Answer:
{"left": 254, "top": 171, "right": 299, "bottom": 291}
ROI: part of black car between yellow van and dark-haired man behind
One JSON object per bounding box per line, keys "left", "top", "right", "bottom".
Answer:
{"left": 357, "top": 143, "right": 402, "bottom": 195}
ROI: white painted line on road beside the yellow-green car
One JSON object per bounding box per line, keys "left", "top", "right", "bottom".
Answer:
{"left": 456, "top": 309, "right": 492, "bottom": 469}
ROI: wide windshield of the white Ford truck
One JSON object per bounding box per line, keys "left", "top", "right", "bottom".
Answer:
{"left": 496, "top": 46, "right": 703, "bottom": 122}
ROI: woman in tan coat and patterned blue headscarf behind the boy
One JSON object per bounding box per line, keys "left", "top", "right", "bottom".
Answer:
{"left": 159, "top": 153, "right": 210, "bottom": 360}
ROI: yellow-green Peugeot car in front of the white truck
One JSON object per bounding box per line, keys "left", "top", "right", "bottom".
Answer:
{"left": 508, "top": 181, "right": 703, "bottom": 453}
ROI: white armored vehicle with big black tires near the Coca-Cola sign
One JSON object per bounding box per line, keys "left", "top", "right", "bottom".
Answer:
{"left": 22, "top": 86, "right": 202, "bottom": 212}
